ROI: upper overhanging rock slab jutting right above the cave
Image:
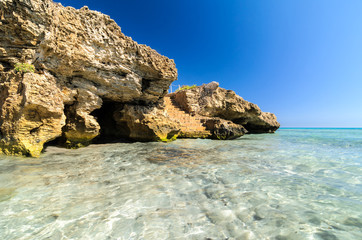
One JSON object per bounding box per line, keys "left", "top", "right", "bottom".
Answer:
{"left": 0, "top": 0, "right": 177, "bottom": 102}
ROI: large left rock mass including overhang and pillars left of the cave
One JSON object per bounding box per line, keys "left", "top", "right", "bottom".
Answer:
{"left": 0, "top": 0, "right": 177, "bottom": 156}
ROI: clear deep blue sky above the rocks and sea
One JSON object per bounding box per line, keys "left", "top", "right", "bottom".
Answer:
{"left": 55, "top": 0, "right": 362, "bottom": 127}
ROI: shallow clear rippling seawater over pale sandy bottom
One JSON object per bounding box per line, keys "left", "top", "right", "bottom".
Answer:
{"left": 0, "top": 129, "right": 362, "bottom": 240}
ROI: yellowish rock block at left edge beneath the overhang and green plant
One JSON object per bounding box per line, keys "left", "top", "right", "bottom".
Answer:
{"left": 0, "top": 73, "right": 65, "bottom": 156}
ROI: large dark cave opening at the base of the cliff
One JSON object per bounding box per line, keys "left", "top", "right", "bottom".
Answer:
{"left": 91, "top": 100, "right": 129, "bottom": 144}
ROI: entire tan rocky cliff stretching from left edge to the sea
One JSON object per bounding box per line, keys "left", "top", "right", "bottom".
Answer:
{"left": 0, "top": 0, "right": 279, "bottom": 156}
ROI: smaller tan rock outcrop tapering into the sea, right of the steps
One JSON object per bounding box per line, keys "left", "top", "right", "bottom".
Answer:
{"left": 170, "top": 82, "right": 280, "bottom": 133}
